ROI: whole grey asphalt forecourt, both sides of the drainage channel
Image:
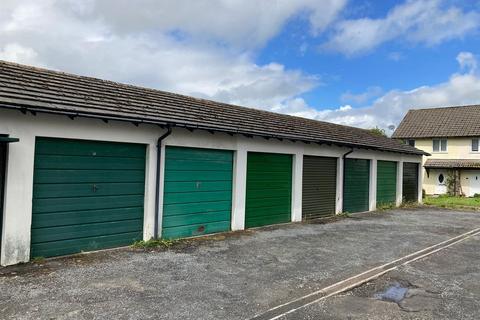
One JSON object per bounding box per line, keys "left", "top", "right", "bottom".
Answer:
{"left": 0, "top": 208, "right": 480, "bottom": 319}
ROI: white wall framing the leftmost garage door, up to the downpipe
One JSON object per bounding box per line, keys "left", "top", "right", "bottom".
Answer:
{"left": 0, "top": 109, "right": 164, "bottom": 265}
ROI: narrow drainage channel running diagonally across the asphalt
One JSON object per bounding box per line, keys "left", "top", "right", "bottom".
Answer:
{"left": 251, "top": 228, "right": 480, "bottom": 320}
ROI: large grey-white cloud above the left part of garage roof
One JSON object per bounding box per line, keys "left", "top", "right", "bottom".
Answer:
{"left": 0, "top": 0, "right": 346, "bottom": 108}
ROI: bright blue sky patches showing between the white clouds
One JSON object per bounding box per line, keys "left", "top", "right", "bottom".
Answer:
{"left": 257, "top": 0, "right": 480, "bottom": 109}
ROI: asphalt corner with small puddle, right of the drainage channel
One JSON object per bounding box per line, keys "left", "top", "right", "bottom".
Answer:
{"left": 280, "top": 232, "right": 480, "bottom": 320}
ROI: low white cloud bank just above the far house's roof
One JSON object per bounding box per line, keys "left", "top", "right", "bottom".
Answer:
{"left": 278, "top": 52, "right": 480, "bottom": 128}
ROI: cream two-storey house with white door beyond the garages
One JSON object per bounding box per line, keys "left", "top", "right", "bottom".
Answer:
{"left": 392, "top": 105, "right": 480, "bottom": 197}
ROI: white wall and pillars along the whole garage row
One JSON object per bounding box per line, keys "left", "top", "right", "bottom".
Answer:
{"left": 0, "top": 110, "right": 422, "bottom": 265}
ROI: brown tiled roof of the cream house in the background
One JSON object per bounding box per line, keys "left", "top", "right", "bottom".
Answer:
{"left": 392, "top": 105, "right": 480, "bottom": 139}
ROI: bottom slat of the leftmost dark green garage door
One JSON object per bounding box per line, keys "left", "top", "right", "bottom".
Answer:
{"left": 31, "top": 232, "right": 139, "bottom": 257}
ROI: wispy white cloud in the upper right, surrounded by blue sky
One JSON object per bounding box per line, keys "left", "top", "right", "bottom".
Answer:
{"left": 322, "top": 0, "right": 480, "bottom": 55}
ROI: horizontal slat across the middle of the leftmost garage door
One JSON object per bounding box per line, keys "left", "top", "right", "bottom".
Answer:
{"left": 33, "top": 182, "right": 145, "bottom": 199}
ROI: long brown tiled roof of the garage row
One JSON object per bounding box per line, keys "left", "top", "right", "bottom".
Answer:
{"left": 0, "top": 61, "right": 424, "bottom": 154}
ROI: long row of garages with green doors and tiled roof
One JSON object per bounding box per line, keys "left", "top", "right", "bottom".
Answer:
{"left": 0, "top": 62, "right": 425, "bottom": 265}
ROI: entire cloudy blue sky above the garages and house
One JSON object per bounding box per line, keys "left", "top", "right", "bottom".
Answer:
{"left": 0, "top": 0, "right": 480, "bottom": 133}
